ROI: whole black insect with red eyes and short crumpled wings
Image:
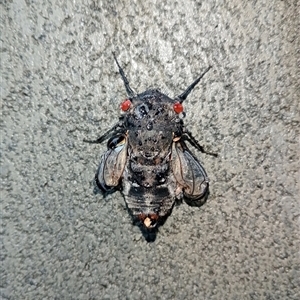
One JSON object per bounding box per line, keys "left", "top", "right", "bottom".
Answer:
{"left": 85, "top": 55, "right": 217, "bottom": 237}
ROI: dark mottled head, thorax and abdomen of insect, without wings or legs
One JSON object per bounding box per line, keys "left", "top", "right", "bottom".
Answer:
{"left": 122, "top": 90, "right": 180, "bottom": 228}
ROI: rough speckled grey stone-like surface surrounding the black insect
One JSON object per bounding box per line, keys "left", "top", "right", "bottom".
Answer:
{"left": 0, "top": 0, "right": 300, "bottom": 299}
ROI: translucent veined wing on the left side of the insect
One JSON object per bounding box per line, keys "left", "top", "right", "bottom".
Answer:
{"left": 95, "top": 134, "right": 128, "bottom": 192}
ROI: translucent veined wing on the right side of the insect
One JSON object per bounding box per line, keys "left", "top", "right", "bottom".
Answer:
{"left": 171, "top": 140, "right": 209, "bottom": 205}
